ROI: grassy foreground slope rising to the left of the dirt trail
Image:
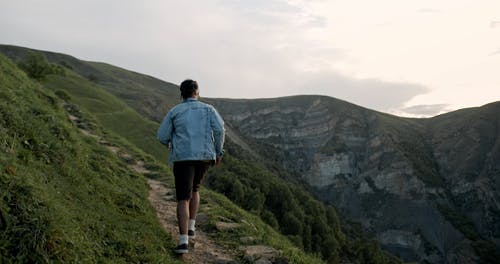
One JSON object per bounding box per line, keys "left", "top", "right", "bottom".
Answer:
{"left": 0, "top": 53, "right": 180, "bottom": 263}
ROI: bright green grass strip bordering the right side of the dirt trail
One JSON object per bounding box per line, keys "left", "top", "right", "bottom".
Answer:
{"left": 19, "top": 51, "right": 328, "bottom": 263}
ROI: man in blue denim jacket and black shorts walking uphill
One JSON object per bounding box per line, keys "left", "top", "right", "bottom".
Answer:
{"left": 158, "top": 80, "right": 224, "bottom": 254}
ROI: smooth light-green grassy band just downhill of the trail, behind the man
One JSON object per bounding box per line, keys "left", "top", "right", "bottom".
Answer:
{"left": 42, "top": 52, "right": 328, "bottom": 263}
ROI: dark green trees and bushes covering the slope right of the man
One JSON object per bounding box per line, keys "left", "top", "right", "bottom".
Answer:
{"left": 207, "top": 142, "right": 399, "bottom": 263}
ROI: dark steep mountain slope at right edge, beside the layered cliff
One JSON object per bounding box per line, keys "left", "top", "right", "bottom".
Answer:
{"left": 425, "top": 102, "right": 500, "bottom": 254}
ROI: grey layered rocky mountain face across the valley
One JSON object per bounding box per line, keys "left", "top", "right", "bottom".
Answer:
{"left": 204, "top": 96, "right": 500, "bottom": 263}
